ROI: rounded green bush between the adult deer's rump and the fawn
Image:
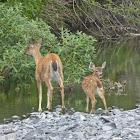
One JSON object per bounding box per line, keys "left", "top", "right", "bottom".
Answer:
{"left": 53, "top": 29, "right": 96, "bottom": 83}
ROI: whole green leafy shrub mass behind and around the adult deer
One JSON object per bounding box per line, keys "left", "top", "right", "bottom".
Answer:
{"left": 0, "top": 5, "right": 96, "bottom": 85}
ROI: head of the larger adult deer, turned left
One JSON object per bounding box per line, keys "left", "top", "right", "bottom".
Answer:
{"left": 25, "top": 38, "right": 42, "bottom": 56}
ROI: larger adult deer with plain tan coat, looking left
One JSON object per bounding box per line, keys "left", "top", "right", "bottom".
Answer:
{"left": 25, "top": 38, "right": 65, "bottom": 112}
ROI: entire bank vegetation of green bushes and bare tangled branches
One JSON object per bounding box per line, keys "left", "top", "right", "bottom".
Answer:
{"left": 0, "top": 0, "right": 140, "bottom": 85}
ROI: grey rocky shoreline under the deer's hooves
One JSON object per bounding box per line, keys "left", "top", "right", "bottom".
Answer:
{"left": 0, "top": 105, "right": 140, "bottom": 140}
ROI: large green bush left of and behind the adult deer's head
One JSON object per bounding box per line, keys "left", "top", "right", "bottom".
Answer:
{"left": 0, "top": 5, "right": 57, "bottom": 80}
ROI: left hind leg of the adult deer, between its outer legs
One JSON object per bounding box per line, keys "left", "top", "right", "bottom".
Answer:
{"left": 45, "top": 80, "right": 53, "bottom": 110}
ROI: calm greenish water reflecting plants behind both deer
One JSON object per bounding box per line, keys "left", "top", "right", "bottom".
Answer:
{"left": 0, "top": 39, "right": 140, "bottom": 123}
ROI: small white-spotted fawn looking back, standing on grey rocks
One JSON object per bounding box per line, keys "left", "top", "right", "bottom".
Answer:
{"left": 82, "top": 61, "right": 108, "bottom": 115}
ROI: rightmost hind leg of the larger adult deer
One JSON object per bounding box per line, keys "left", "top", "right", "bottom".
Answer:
{"left": 59, "top": 78, "right": 65, "bottom": 113}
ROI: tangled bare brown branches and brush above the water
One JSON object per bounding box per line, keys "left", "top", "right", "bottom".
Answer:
{"left": 41, "top": 0, "right": 140, "bottom": 38}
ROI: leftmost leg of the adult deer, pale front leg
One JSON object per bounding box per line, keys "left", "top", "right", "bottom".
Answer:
{"left": 37, "top": 81, "right": 42, "bottom": 112}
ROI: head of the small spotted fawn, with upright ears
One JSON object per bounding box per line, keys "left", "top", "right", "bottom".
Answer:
{"left": 89, "top": 61, "right": 106, "bottom": 78}
